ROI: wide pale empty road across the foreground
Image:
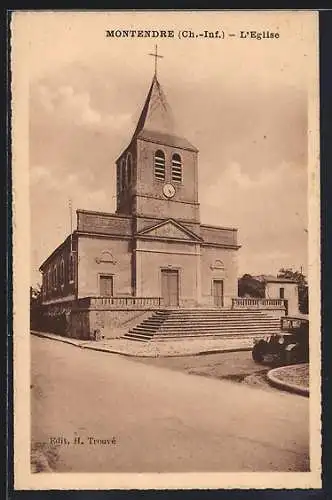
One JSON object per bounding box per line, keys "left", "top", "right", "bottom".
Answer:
{"left": 31, "top": 336, "right": 309, "bottom": 472}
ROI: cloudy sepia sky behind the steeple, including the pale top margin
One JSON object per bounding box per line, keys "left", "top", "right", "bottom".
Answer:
{"left": 15, "top": 12, "right": 314, "bottom": 284}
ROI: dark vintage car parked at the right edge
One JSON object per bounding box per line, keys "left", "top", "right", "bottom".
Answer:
{"left": 252, "top": 316, "right": 309, "bottom": 365}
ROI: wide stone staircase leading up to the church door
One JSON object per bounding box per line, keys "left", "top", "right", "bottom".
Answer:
{"left": 122, "top": 308, "right": 280, "bottom": 342}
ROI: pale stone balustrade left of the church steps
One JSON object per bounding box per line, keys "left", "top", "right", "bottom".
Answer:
{"left": 78, "top": 297, "right": 163, "bottom": 309}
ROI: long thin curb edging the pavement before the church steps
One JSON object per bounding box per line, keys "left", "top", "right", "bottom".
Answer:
{"left": 30, "top": 330, "right": 252, "bottom": 358}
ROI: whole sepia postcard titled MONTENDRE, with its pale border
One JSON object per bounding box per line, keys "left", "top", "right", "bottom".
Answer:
{"left": 10, "top": 11, "right": 321, "bottom": 490}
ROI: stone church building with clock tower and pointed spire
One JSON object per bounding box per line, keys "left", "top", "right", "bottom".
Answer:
{"left": 40, "top": 75, "right": 240, "bottom": 308}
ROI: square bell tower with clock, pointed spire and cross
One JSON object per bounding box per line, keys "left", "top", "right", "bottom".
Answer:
{"left": 116, "top": 47, "right": 199, "bottom": 223}
